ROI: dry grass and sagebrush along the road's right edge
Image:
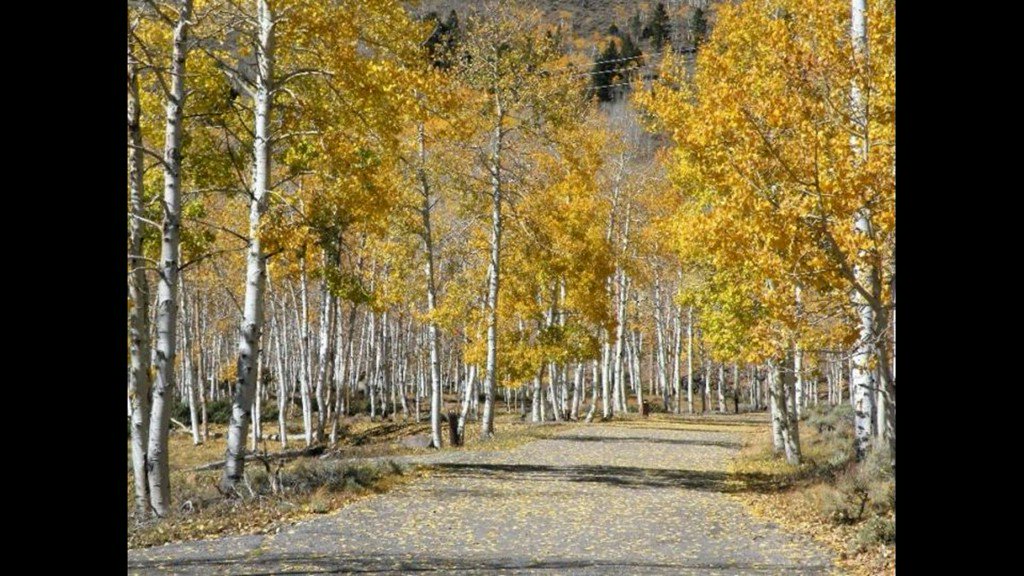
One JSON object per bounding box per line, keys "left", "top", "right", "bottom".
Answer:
{"left": 730, "top": 405, "right": 896, "bottom": 576}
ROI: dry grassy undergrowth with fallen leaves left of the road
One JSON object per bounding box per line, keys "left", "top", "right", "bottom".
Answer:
{"left": 127, "top": 413, "right": 563, "bottom": 548}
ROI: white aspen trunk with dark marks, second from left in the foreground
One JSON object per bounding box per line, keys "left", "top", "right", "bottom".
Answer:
{"left": 147, "top": 0, "right": 191, "bottom": 518}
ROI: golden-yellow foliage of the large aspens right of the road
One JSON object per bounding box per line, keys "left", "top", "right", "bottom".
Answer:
{"left": 637, "top": 0, "right": 896, "bottom": 360}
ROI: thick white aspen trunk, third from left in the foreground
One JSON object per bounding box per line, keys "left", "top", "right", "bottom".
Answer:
{"left": 220, "top": 0, "right": 274, "bottom": 492}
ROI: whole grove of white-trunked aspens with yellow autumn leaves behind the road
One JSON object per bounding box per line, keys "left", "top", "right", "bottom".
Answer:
{"left": 126, "top": 0, "right": 896, "bottom": 537}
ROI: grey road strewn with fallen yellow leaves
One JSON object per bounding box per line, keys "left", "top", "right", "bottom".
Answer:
{"left": 128, "top": 415, "right": 833, "bottom": 574}
